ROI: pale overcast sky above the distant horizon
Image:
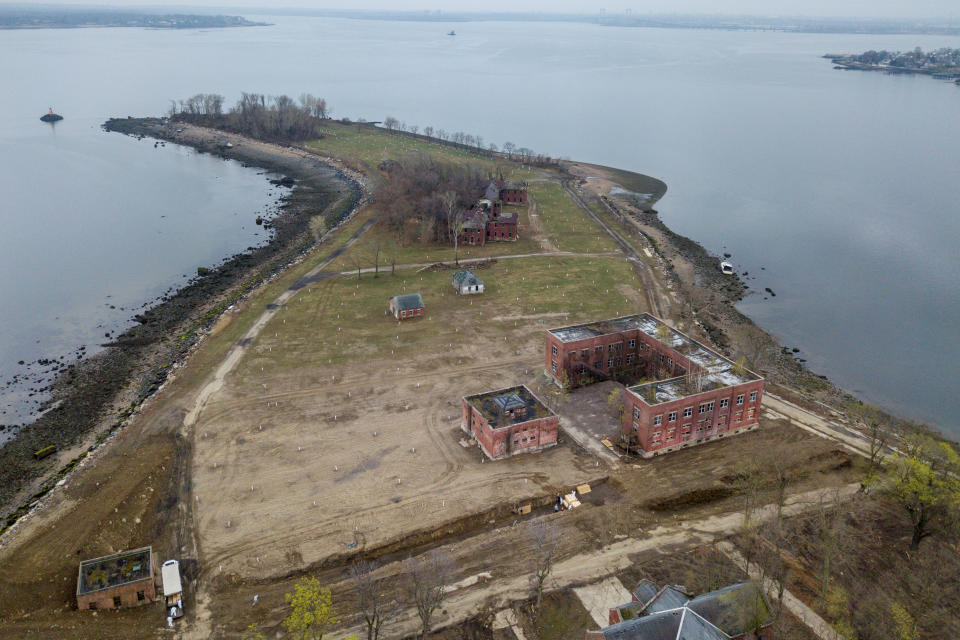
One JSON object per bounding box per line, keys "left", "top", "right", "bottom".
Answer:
{"left": 13, "top": 0, "right": 960, "bottom": 18}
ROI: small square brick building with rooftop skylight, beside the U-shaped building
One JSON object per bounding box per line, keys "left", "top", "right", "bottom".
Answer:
{"left": 460, "top": 386, "right": 560, "bottom": 459}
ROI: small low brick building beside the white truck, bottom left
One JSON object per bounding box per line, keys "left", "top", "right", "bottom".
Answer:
{"left": 77, "top": 547, "right": 157, "bottom": 610}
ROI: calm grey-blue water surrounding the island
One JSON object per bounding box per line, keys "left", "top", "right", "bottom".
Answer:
{"left": 0, "top": 18, "right": 960, "bottom": 435}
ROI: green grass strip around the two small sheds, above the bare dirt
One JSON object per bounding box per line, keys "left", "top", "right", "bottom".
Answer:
{"left": 229, "top": 252, "right": 642, "bottom": 384}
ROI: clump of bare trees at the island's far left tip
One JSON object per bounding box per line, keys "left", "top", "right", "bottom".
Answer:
{"left": 167, "top": 92, "right": 330, "bottom": 141}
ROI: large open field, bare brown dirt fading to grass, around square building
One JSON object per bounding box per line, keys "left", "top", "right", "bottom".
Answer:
{"left": 193, "top": 259, "right": 630, "bottom": 578}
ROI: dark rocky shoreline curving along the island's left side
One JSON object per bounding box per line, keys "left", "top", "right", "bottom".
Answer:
{"left": 0, "top": 118, "right": 363, "bottom": 531}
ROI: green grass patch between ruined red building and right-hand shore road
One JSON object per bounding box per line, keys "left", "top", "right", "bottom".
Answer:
{"left": 528, "top": 182, "right": 617, "bottom": 253}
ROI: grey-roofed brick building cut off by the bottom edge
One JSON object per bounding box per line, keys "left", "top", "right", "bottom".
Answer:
{"left": 586, "top": 580, "right": 773, "bottom": 640}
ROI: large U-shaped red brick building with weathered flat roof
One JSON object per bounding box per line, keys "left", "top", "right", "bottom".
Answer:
{"left": 546, "top": 313, "right": 764, "bottom": 456}
